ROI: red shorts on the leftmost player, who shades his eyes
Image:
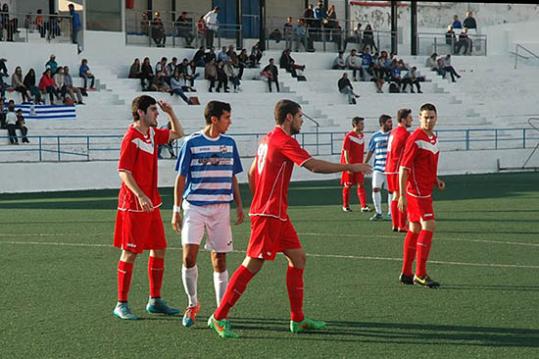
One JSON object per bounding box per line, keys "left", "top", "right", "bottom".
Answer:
{"left": 114, "top": 208, "right": 167, "bottom": 253}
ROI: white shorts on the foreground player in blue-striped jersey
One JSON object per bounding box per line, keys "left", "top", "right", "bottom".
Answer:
{"left": 181, "top": 201, "right": 233, "bottom": 253}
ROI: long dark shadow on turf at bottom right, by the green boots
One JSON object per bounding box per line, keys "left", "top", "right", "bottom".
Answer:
{"left": 232, "top": 318, "right": 539, "bottom": 348}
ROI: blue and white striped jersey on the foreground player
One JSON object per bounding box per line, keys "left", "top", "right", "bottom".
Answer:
{"left": 176, "top": 132, "right": 243, "bottom": 206}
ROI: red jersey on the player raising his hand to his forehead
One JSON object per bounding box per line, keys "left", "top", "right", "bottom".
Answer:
{"left": 118, "top": 125, "right": 170, "bottom": 212}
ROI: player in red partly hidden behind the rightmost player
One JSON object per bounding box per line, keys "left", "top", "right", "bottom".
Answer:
{"left": 386, "top": 108, "right": 414, "bottom": 232}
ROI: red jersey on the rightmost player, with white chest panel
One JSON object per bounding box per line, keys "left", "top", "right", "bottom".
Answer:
{"left": 400, "top": 128, "right": 440, "bottom": 197}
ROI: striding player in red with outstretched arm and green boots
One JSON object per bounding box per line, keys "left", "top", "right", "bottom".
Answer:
{"left": 208, "top": 100, "right": 370, "bottom": 338}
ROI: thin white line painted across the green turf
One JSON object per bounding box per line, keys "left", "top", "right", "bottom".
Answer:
{"left": 0, "top": 240, "right": 539, "bottom": 269}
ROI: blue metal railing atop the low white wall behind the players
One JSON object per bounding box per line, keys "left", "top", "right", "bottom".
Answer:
{"left": 0, "top": 128, "right": 539, "bottom": 163}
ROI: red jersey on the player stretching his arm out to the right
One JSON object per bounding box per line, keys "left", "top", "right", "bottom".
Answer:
{"left": 249, "top": 126, "right": 312, "bottom": 221}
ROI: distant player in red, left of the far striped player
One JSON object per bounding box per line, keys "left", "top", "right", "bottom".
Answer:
{"left": 341, "top": 117, "right": 370, "bottom": 212}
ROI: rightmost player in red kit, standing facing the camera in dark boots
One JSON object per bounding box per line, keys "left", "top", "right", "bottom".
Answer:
{"left": 398, "top": 103, "right": 445, "bottom": 288}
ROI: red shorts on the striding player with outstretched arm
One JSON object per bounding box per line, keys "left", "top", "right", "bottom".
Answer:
{"left": 247, "top": 216, "right": 301, "bottom": 260}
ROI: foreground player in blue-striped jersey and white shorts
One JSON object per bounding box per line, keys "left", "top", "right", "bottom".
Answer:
{"left": 172, "top": 101, "right": 244, "bottom": 327}
